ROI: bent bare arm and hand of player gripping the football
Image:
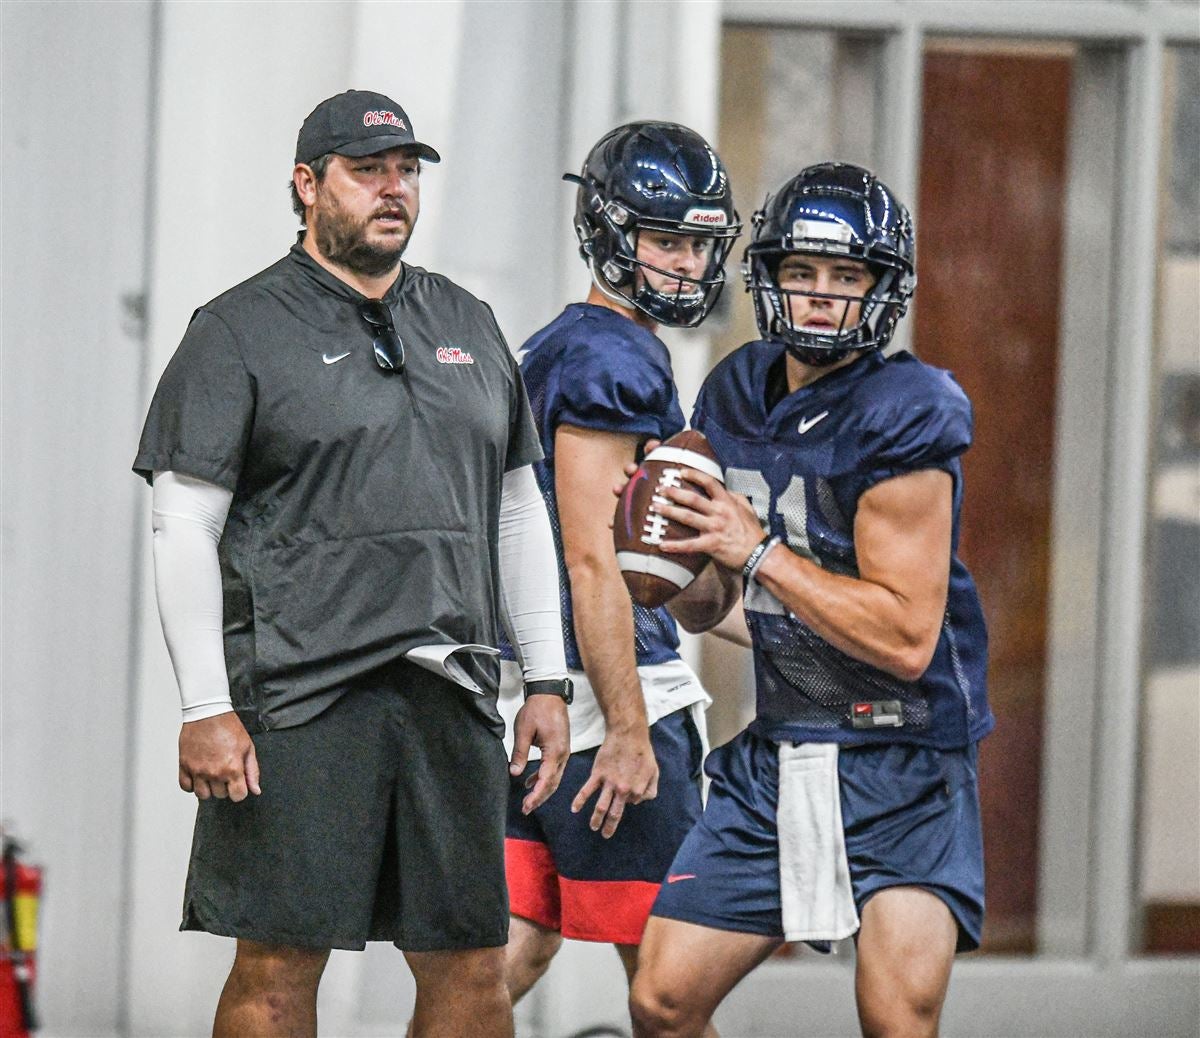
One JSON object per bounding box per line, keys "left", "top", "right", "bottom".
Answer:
{"left": 664, "top": 469, "right": 952, "bottom": 680}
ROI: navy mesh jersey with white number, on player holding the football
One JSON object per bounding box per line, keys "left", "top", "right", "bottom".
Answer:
{"left": 692, "top": 342, "right": 994, "bottom": 748}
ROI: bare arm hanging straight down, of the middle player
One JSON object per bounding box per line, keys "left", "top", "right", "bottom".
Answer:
{"left": 554, "top": 425, "right": 658, "bottom": 835}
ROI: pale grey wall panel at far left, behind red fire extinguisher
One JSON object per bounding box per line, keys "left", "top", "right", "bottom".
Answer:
{"left": 0, "top": 2, "right": 154, "bottom": 1034}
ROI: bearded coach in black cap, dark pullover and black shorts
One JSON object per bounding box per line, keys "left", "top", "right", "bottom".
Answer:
{"left": 133, "top": 90, "right": 570, "bottom": 1038}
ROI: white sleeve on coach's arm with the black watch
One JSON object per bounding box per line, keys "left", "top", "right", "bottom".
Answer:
{"left": 500, "top": 466, "right": 566, "bottom": 682}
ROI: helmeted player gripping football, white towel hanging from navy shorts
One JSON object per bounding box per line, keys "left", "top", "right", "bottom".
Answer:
{"left": 631, "top": 163, "right": 994, "bottom": 1038}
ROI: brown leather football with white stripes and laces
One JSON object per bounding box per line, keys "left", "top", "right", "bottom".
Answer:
{"left": 612, "top": 430, "right": 725, "bottom": 608}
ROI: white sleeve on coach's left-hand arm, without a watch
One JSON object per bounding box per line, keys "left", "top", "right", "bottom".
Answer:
{"left": 152, "top": 472, "right": 233, "bottom": 721}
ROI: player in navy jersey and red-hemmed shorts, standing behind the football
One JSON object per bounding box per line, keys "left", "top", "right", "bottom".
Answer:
{"left": 500, "top": 122, "right": 740, "bottom": 1027}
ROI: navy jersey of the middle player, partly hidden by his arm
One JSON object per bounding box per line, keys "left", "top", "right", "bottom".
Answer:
{"left": 500, "top": 302, "right": 684, "bottom": 670}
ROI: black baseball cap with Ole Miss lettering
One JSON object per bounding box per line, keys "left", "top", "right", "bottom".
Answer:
{"left": 296, "top": 90, "right": 442, "bottom": 163}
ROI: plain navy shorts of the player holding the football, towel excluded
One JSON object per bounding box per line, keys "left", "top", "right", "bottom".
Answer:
{"left": 653, "top": 732, "right": 983, "bottom": 952}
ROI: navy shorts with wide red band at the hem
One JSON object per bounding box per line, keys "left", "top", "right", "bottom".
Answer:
{"left": 505, "top": 707, "right": 702, "bottom": 944}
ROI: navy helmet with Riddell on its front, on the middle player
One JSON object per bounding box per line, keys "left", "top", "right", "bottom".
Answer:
{"left": 563, "top": 122, "right": 742, "bottom": 328}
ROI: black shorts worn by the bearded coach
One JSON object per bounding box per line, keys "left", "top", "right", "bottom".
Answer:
{"left": 180, "top": 662, "right": 509, "bottom": 952}
